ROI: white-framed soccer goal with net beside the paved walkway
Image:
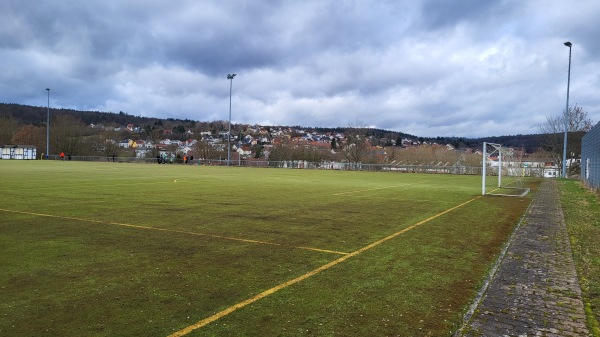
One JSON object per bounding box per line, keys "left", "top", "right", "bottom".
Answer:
{"left": 481, "top": 142, "right": 529, "bottom": 197}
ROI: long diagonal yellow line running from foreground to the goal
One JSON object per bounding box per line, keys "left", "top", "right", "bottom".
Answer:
{"left": 168, "top": 195, "right": 482, "bottom": 337}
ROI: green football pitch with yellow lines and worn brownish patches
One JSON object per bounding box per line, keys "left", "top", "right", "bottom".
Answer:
{"left": 0, "top": 160, "right": 539, "bottom": 336}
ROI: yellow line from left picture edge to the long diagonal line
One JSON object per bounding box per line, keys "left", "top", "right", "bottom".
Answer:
{"left": 0, "top": 208, "right": 348, "bottom": 255}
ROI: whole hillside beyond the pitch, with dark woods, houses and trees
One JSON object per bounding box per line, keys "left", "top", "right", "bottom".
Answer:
{"left": 0, "top": 104, "right": 577, "bottom": 173}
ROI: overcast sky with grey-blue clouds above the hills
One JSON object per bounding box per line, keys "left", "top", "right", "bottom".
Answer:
{"left": 0, "top": 0, "right": 600, "bottom": 137}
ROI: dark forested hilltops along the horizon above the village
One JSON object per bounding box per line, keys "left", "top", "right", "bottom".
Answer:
{"left": 0, "top": 103, "right": 543, "bottom": 153}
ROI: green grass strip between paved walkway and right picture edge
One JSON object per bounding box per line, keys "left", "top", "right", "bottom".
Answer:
{"left": 560, "top": 180, "right": 600, "bottom": 336}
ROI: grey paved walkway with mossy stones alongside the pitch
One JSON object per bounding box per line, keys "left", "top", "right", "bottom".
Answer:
{"left": 456, "top": 179, "right": 590, "bottom": 337}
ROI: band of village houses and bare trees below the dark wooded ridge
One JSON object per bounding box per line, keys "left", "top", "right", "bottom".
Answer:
{"left": 1, "top": 122, "right": 557, "bottom": 177}
